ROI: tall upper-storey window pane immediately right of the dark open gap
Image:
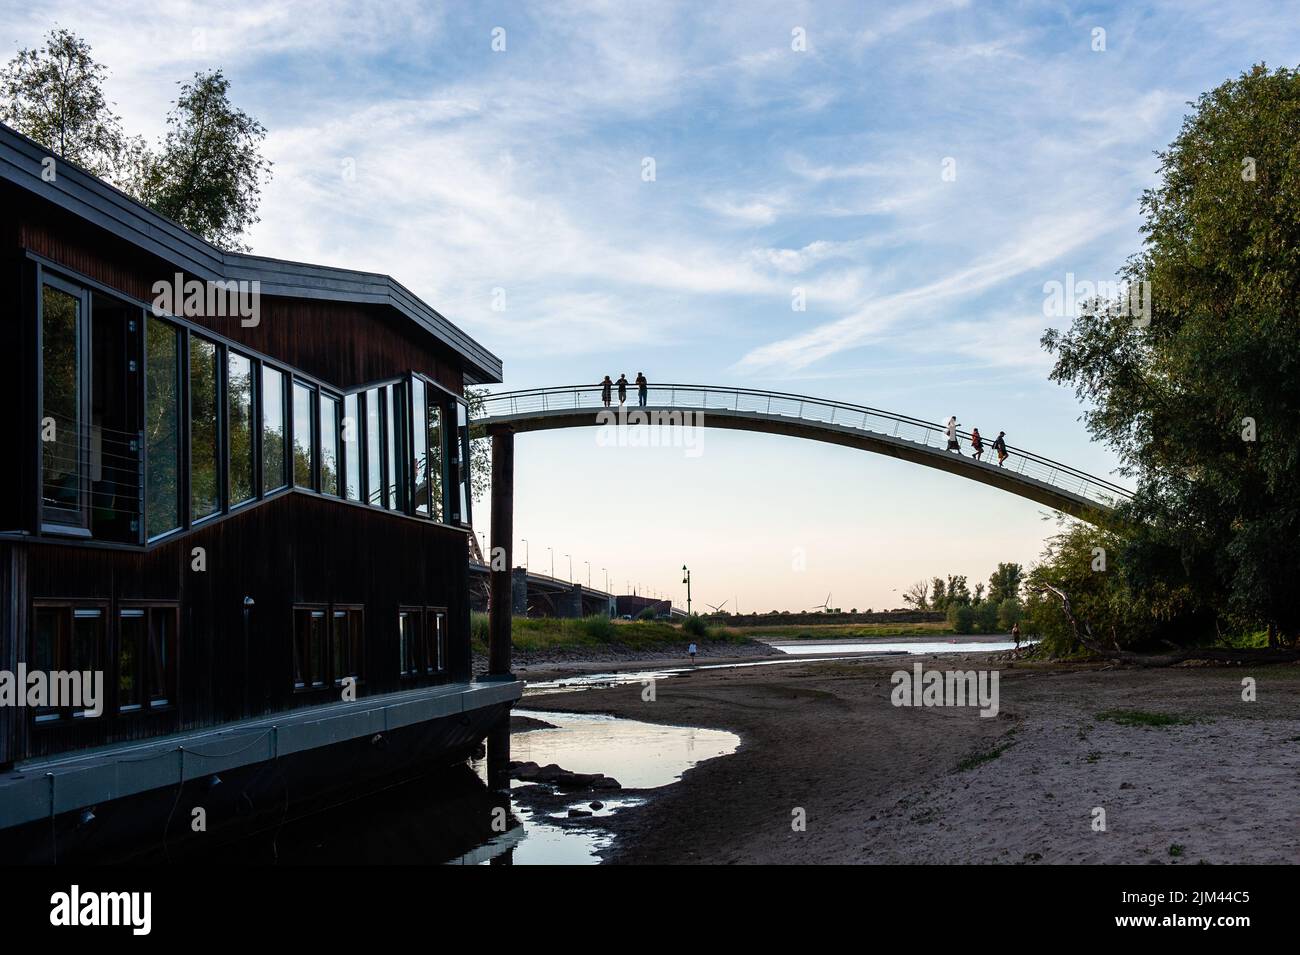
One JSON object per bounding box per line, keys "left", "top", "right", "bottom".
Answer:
{"left": 144, "top": 316, "right": 181, "bottom": 538}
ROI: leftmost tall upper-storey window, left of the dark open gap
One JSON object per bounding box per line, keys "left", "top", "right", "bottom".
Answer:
{"left": 40, "top": 285, "right": 87, "bottom": 525}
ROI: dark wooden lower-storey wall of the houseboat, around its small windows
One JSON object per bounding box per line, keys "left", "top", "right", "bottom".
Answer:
{"left": 14, "top": 491, "right": 471, "bottom": 756}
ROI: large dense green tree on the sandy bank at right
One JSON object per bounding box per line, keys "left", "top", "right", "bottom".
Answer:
{"left": 1031, "top": 64, "right": 1300, "bottom": 643}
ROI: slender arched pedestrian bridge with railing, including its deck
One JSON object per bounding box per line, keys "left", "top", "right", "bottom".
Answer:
{"left": 473, "top": 385, "right": 1131, "bottom": 520}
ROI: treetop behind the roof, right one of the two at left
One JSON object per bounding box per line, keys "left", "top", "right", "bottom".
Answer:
{"left": 131, "top": 70, "right": 270, "bottom": 251}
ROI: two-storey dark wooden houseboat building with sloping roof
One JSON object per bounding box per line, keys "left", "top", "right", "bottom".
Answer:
{"left": 0, "top": 126, "right": 519, "bottom": 857}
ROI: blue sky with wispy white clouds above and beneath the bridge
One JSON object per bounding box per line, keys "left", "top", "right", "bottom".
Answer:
{"left": 0, "top": 0, "right": 1300, "bottom": 611}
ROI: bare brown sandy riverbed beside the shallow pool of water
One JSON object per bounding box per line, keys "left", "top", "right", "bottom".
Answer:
{"left": 525, "top": 652, "right": 1300, "bottom": 864}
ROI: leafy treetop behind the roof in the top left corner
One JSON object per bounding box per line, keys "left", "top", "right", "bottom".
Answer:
{"left": 0, "top": 29, "right": 126, "bottom": 178}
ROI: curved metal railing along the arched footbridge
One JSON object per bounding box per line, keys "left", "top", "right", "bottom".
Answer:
{"left": 475, "top": 383, "right": 1132, "bottom": 505}
